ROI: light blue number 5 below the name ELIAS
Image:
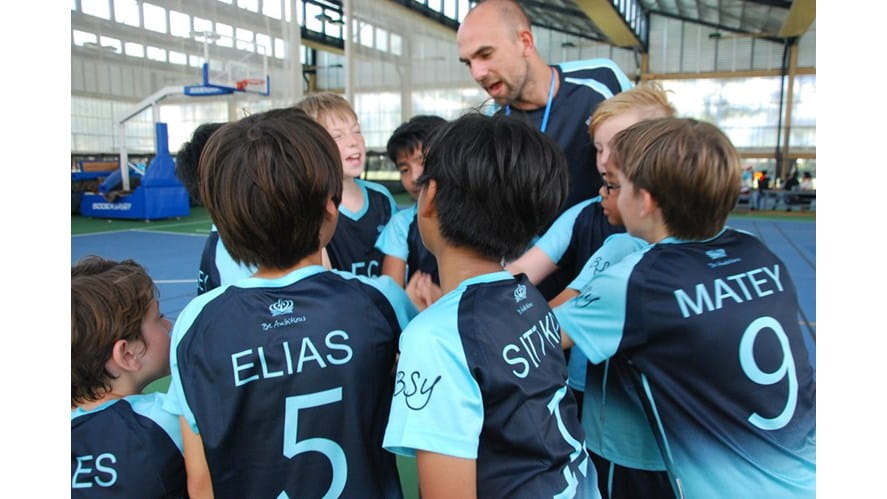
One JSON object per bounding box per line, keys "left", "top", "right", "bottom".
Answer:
{"left": 277, "top": 386, "right": 348, "bottom": 499}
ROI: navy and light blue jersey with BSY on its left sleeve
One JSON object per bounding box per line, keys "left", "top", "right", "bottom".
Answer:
{"left": 383, "top": 271, "right": 596, "bottom": 497}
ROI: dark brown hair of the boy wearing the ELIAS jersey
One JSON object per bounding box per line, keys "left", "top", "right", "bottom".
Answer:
{"left": 199, "top": 108, "right": 342, "bottom": 269}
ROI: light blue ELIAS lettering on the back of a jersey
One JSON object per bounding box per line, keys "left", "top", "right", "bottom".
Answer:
{"left": 231, "top": 329, "right": 354, "bottom": 387}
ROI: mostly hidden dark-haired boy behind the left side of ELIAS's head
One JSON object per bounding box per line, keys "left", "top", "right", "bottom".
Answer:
{"left": 176, "top": 123, "right": 256, "bottom": 295}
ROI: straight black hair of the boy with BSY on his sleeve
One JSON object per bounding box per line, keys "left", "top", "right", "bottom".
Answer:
{"left": 416, "top": 113, "right": 569, "bottom": 260}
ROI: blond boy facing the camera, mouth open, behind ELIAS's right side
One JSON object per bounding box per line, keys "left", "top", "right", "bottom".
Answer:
{"left": 296, "top": 92, "right": 397, "bottom": 277}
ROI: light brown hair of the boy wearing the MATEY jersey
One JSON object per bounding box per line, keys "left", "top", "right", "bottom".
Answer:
{"left": 610, "top": 118, "right": 742, "bottom": 240}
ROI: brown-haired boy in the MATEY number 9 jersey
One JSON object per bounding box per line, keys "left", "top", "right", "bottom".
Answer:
{"left": 555, "top": 118, "right": 816, "bottom": 497}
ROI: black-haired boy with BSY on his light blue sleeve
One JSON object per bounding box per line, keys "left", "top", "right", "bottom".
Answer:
{"left": 384, "top": 114, "right": 594, "bottom": 499}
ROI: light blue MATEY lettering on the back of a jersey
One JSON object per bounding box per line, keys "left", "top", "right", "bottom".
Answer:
{"left": 674, "top": 264, "right": 783, "bottom": 319}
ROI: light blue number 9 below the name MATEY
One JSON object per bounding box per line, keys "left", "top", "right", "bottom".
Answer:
{"left": 739, "top": 316, "right": 798, "bottom": 430}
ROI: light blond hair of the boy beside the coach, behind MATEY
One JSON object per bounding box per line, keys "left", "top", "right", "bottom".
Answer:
{"left": 588, "top": 81, "right": 677, "bottom": 136}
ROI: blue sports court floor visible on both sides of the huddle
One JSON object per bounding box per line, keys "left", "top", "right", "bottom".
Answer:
{"left": 71, "top": 217, "right": 816, "bottom": 366}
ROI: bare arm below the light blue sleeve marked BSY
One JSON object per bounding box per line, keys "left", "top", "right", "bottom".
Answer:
{"left": 416, "top": 450, "right": 477, "bottom": 499}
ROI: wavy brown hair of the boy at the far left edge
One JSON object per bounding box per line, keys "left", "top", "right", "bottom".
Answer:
{"left": 71, "top": 255, "right": 157, "bottom": 407}
